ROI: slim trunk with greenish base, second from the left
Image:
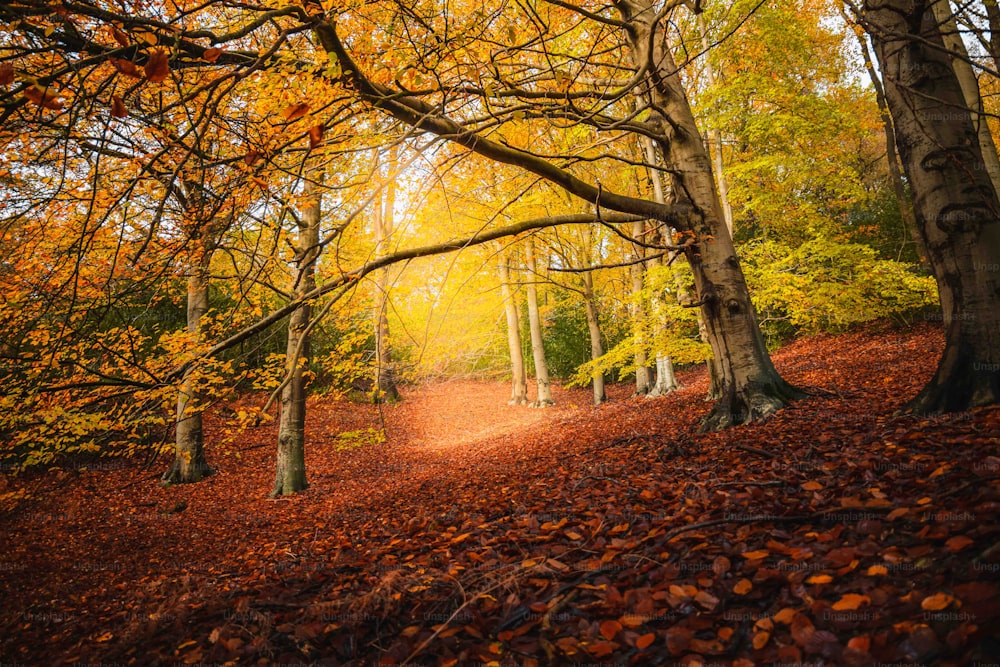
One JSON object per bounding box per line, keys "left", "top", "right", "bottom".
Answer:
{"left": 271, "top": 181, "right": 322, "bottom": 498}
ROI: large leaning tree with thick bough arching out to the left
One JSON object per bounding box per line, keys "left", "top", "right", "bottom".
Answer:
{"left": 316, "top": 0, "right": 802, "bottom": 429}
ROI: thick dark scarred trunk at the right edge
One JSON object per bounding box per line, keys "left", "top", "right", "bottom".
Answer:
{"left": 862, "top": 0, "right": 1000, "bottom": 413}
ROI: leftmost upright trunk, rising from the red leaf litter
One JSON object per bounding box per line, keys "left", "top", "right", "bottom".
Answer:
{"left": 161, "top": 256, "right": 213, "bottom": 484}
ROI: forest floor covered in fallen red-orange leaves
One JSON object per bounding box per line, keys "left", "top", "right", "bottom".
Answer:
{"left": 0, "top": 324, "right": 1000, "bottom": 666}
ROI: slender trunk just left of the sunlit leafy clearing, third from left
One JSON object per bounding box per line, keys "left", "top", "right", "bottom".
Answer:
{"left": 374, "top": 146, "right": 400, "bottom": 402}
